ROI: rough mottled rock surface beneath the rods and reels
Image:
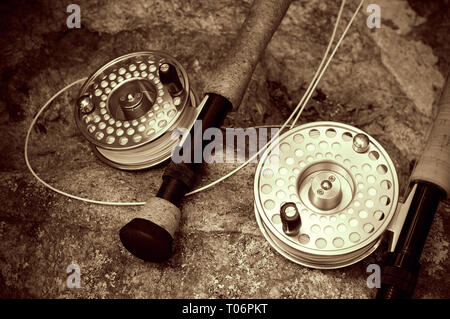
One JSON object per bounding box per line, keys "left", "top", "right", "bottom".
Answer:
{"left": 0, "top": 0, "right": 450, "bottom": 298}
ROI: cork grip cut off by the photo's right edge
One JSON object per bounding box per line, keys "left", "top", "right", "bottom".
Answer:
{"left": 411, "top": 72, "right": 450, "bottom": 197}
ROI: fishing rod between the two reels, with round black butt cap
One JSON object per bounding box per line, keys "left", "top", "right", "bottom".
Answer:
{"left": 116, "top": 0, "right": 291, "bottom": 262}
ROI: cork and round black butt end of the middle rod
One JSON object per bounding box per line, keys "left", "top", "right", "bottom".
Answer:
{"left": 119, "top": 197, "right": 181, "bottom": 262}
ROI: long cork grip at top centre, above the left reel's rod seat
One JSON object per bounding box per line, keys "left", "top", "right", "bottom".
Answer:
{"left": 204, "top": 0, "right": 292, "bottom": 109}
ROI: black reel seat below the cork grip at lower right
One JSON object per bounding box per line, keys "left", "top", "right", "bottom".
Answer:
{"left": 376, "top": 182, "right": 444, "bottom": 299}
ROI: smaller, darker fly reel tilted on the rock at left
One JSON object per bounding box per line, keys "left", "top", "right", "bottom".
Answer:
{"left": 75, "top": 51, "right": 197, "bottom": 170}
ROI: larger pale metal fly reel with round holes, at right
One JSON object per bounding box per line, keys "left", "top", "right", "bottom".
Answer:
{"left": 254, "top": 122, "right": 399, "bottom": 269}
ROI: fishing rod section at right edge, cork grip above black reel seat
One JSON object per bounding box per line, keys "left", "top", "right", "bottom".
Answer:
{"left": 376, "top": 72, "right": 450, "bottom": 299}
